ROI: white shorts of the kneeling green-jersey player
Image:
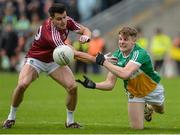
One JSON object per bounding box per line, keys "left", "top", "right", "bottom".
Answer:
{"left": 128, "top": 84, "right": 165, "bottom": 105}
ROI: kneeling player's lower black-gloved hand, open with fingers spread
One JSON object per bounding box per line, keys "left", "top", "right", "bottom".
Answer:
{"left": 76, "top": 75, "right": 96, "bottom": 89}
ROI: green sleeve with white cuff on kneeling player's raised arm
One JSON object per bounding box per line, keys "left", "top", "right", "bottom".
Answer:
{"left": 130, "top": 50, "right": 150, "bottom": 66}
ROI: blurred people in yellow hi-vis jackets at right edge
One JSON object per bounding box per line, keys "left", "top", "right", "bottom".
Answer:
{"left": 137, "top": 27, "right": 180, "bottom": 77}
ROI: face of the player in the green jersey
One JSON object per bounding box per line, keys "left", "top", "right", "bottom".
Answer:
{"left": 118, "top": 35, "right": 135, "bottom": 55}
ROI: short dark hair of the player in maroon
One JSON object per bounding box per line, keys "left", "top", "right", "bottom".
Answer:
{"left": 49, "top": 3, "right": 66, "bottom": 17}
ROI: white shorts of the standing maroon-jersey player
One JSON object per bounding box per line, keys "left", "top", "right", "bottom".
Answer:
{"left": 25, "top": 58, "right": 60, "bottom": 74}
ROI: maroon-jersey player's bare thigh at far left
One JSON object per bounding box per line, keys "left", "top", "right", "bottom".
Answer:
{"left": 18, "top": 64, "right": 38, "bottom": 85}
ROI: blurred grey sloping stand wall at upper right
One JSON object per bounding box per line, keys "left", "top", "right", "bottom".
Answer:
{"left": 80, "top": 0, "right": 180, "bottom": 50}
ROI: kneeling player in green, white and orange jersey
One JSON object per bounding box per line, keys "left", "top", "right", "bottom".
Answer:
{"left": 76, "top": 27, "right": 164, "bottom": 129}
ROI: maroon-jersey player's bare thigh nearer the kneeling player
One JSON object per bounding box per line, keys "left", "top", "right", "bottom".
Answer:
{"left": 49, "top": 66, "right": 76, "bottom": 89}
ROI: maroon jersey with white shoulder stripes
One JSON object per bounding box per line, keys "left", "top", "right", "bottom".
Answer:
{"left": 26, "top": 17, "right": 80, "bottom": 63}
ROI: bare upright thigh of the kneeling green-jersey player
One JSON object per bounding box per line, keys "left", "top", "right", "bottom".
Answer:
{"left": 128, "top": 102, "right": 144, "bottom": 129}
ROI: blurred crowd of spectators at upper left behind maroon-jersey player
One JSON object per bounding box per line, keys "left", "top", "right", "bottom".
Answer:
{"left": 0, "top": 0, "right": 120, "bottom": 72}
